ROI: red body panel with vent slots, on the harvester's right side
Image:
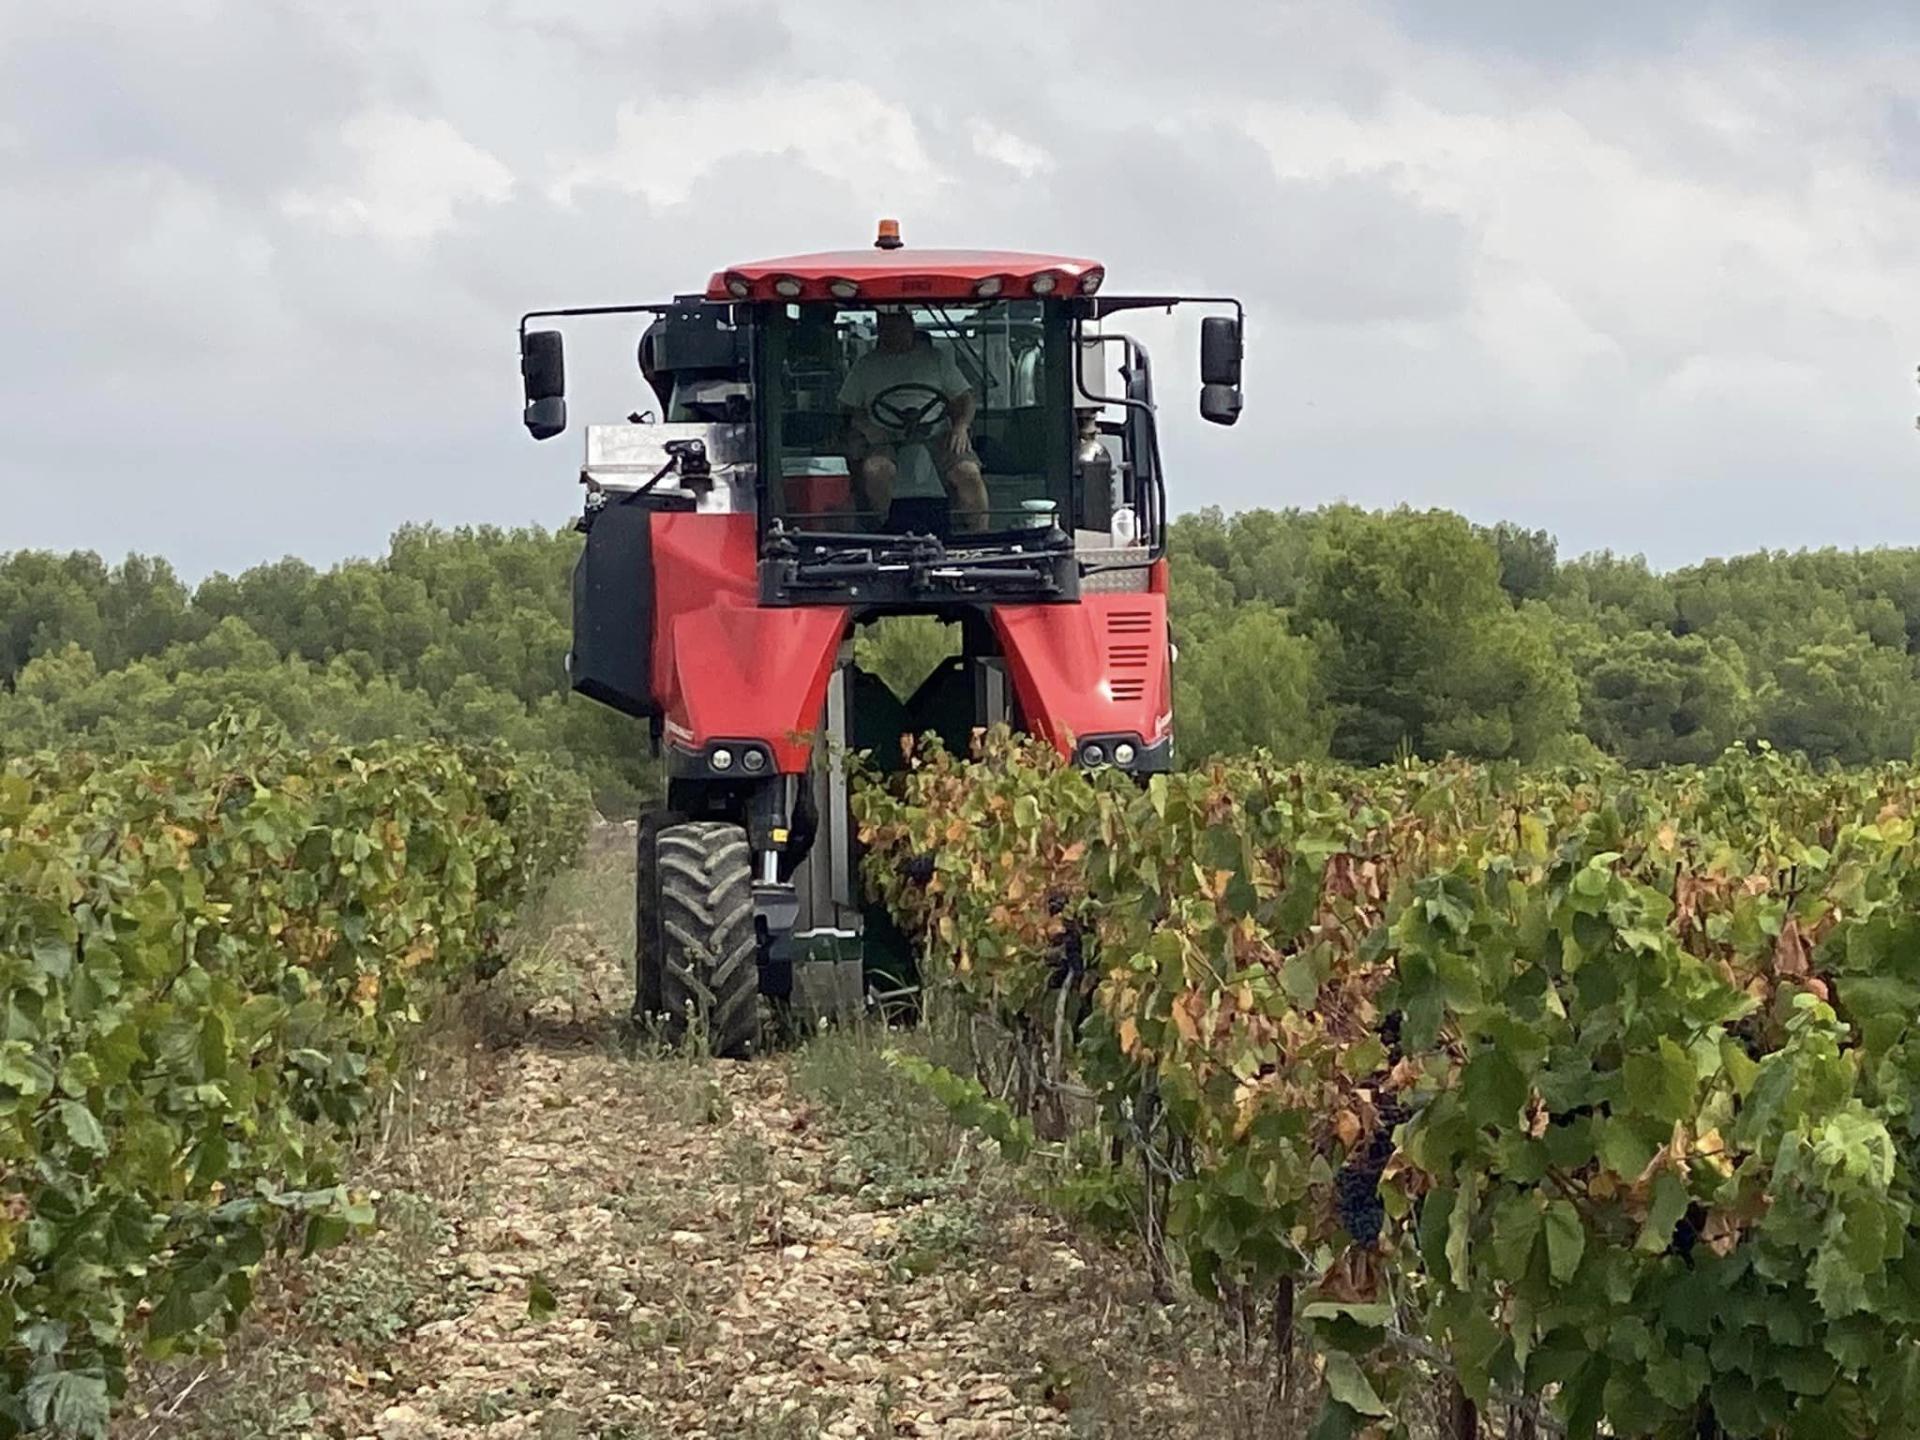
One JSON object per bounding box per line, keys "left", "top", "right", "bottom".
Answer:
{"left": 993, "top": 593, "right": 1173, "bottom": 755}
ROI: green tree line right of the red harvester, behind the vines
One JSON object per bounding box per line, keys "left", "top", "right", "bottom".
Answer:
{"left": 1171, "top": 507, "right": 1920, "bottom": 779}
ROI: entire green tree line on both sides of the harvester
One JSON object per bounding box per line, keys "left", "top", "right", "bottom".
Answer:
{"left": 11, "top": 507, "right": 1920, "bottom": 808}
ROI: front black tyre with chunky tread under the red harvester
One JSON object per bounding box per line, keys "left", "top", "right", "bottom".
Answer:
{"left": 655, "top": 820, "right": 760, "bottom": 1058}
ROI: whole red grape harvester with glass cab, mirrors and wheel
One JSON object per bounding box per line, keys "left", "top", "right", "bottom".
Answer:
{"left": 520, "top": 221, "right": 1242, "bottom": 1052}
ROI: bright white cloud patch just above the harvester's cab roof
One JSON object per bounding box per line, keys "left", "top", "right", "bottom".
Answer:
{"left": 551, "top": 79, "right": 941, "bottom": 205}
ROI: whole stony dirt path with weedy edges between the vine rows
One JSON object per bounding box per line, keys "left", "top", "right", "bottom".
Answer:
{"left": 127, "top": 844, "right": 1259, "bottom": 1440}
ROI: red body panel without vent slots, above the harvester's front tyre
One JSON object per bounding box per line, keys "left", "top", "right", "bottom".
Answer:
{"left": 653, "top": 513, "right": 847, "bottom": 774}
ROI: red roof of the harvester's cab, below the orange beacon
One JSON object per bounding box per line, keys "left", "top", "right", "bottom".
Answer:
{"left": 707, "top": 248, "right": 1104, "bottom": 300}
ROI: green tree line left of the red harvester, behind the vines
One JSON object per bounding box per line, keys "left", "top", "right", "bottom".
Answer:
{"left": 0, "top": 526, "right": 655, "bottom": 810}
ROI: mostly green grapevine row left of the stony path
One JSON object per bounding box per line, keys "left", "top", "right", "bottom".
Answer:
{"left": 0, "top": 722, "right": 586, "bottom": 1434}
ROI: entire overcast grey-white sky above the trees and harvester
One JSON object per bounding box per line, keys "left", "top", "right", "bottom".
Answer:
{"left": 0, "top": 0, "right": 1920, "bottom": 578}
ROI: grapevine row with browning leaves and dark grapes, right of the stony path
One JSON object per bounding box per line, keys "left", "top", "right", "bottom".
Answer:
{"left": 856, "top": 735, "right": 1920, "bottom": 1440}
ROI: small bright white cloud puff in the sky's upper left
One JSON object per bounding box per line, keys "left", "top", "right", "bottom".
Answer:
{"left": 280, "top": 109, "right": 513, "bottom": 246}
